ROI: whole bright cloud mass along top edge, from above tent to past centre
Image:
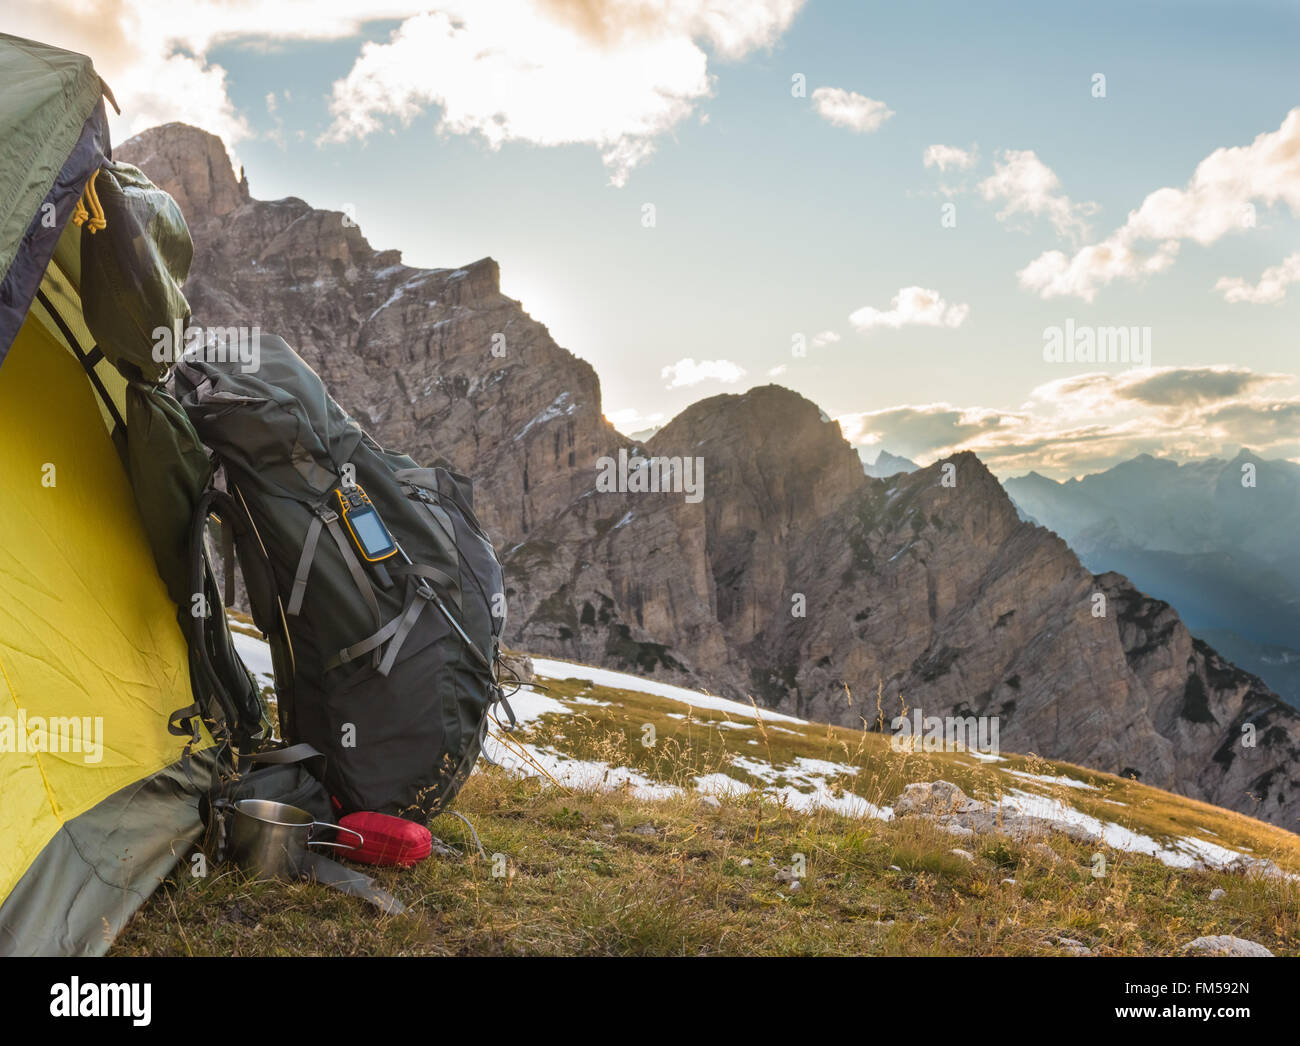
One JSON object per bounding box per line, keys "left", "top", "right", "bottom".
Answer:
{"left": 4, "top": 0, "right": 805, "bottom": 182}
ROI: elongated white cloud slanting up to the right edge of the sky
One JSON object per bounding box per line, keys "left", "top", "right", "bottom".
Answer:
{"left": 1019, "top": 108, "right": 1300, "bottom": 301}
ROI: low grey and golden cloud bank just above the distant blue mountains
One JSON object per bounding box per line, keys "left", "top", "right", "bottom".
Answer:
{"left": 836, "top": 366, "right": 1300, "bottom": 478}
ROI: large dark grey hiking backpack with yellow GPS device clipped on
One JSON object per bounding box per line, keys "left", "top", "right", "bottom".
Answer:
{"left": 174, "top": 334, "right": 514, "bottom": 820}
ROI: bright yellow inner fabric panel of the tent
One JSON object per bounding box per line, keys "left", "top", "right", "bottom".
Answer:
{"left": 0, "top": 314, "right": 191, "bottom": 898}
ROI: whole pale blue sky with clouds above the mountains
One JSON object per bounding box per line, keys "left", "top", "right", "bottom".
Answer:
{"left": 12, "top": 0, "right": 1300, "bottom": 478}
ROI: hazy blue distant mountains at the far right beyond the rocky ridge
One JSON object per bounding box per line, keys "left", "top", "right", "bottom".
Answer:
{"left": 1005, "top": 450, "right": 1300, "bottom": 707}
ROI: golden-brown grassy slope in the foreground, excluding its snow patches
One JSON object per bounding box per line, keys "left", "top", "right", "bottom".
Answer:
{"left": 114, "top": 665, "right": 1300, "bottom": 955}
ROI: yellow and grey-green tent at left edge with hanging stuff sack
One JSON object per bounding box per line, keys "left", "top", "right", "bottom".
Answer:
{"left": 0, "top": 35, "right": 256, "bottom": 955}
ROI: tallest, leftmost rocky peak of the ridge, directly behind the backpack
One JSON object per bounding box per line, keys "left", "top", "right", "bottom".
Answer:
{"left": 114, "top": 123, "right": 620, "bottom": 543}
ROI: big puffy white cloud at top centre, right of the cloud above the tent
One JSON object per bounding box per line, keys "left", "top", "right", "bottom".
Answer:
{"left": 322, "top": 0, "right": 803, "bottom": 186}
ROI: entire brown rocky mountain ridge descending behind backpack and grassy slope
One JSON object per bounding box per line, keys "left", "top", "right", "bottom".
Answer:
{"left": 117, "top": 125, "right": 1300, "bottom": 826}
